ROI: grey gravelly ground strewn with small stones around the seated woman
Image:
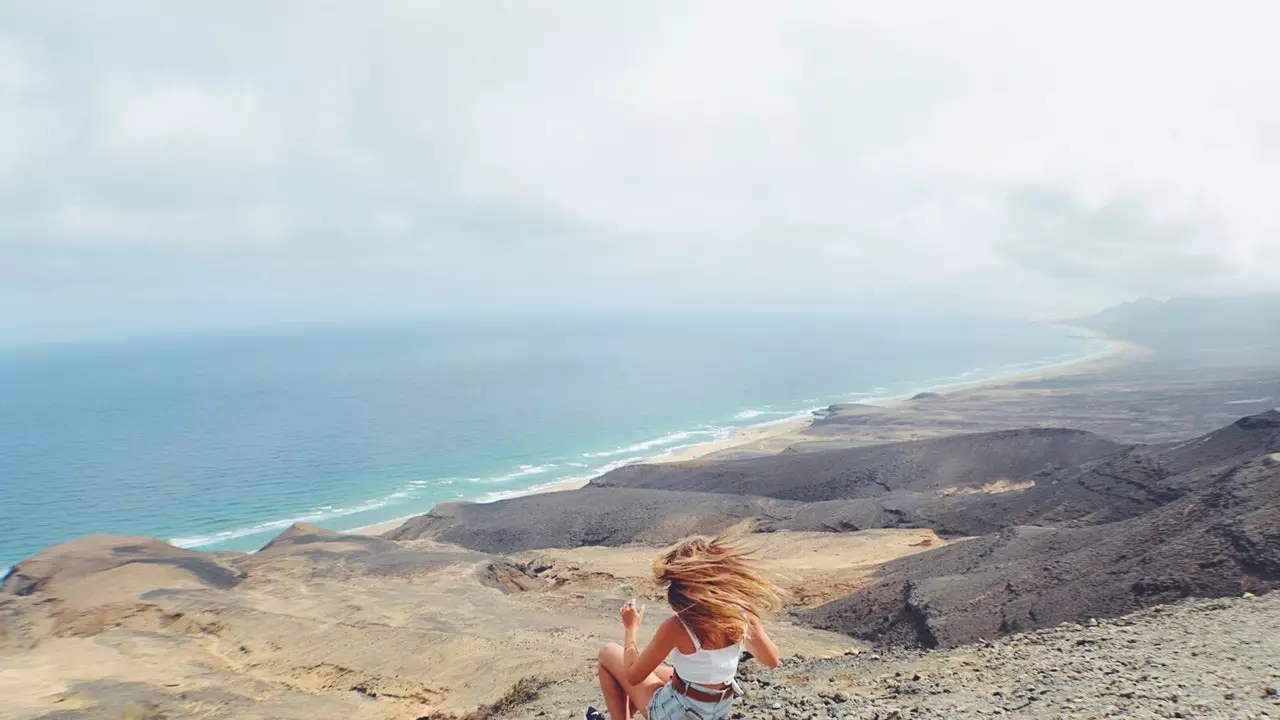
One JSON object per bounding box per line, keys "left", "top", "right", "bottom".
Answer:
{"left": 517, "top": 593, "right": 1280, "bottom": 720}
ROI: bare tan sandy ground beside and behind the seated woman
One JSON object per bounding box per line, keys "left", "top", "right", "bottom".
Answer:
{"left": 0, "top": 530, "right": 946, "bottom": 719}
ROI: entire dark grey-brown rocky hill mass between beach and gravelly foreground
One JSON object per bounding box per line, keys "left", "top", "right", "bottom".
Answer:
{"left": 388, "top": 410, "right": 1280, "bottom": 647}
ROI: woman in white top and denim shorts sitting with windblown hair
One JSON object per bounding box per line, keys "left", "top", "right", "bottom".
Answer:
{"left": 586, "top": 527, "right": 781, "bottom": 720}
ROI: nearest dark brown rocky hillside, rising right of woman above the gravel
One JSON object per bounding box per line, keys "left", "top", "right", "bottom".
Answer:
{"left": 804, "top": 459, "right": 1280, "bottom": 647}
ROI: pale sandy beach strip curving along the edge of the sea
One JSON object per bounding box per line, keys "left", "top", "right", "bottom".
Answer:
{"left": 353, "top": 325, "right": 1151, "bottom": 536}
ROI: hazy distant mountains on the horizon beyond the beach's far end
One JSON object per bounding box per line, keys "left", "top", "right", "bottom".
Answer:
{"left": 1070, "top": 295, "right": 1280, "bottom": 364}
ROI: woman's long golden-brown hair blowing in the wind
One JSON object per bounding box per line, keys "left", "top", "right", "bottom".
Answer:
{"left": 653, "top": 524, "right": 782, "bottom": 647}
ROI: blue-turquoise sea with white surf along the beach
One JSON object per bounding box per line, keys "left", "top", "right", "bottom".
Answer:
{"left": 0, "top": 316, "right": 1105, "bottom": 569}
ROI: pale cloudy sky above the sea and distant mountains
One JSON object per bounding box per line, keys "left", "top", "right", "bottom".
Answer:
{"left": 0, "top": 0, "right": 1280, "bottom": 340}
